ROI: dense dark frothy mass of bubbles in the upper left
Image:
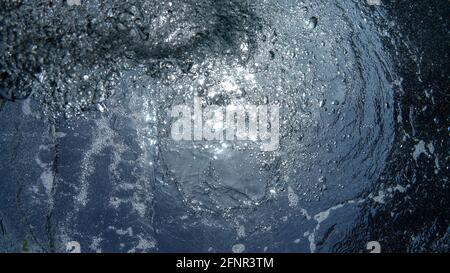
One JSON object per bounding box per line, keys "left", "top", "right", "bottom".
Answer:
{"left": 0, "top": 0, "right": 262, "bottom": 117}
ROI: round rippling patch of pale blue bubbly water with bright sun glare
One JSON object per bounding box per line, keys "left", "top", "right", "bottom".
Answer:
{"left": 149, "top": 2, "right": 400, "bottom": 214}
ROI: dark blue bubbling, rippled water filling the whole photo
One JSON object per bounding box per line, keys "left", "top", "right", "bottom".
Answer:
{"left": 0, "top": 0, "right": 450, "bottom": 252}
